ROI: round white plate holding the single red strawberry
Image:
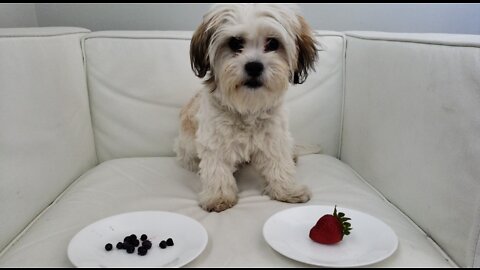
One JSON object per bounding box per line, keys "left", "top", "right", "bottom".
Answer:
{"left": 263, "top": 205, "right": 398, "bottom": 267}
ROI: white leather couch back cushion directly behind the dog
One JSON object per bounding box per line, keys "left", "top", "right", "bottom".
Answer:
{"left": 84, "top": 31, "right": 344, "bottom": 161}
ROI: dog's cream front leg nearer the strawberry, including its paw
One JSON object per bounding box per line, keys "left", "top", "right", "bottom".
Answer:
{"left": 252, "top": 140, "right": 311, "bottom": 203}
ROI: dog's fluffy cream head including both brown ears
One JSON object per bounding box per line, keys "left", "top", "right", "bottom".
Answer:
{"left": 190, "top": 4, "right": 317, "bottom": 113}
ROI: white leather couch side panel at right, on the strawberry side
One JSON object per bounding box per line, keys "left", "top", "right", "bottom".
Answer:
{"left": 341, "top": 32, "right": 480, "bottom": 267}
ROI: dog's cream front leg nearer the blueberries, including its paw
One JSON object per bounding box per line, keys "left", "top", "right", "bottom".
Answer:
{"left": 199, "top": 153, "right": 238, "bottom": 212}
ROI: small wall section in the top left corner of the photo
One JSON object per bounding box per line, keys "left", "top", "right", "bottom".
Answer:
{"left": 0, "top": 3, "right": 38, "bottom": 28}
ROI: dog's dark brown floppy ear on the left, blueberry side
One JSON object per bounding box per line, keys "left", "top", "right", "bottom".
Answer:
{"left": 190, "top": 17, "right": 214, "bottom": 78}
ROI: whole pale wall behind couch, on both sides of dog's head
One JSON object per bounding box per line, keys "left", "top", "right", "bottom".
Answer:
{"left": 4, "top": 3, "right": 480, "bottom": 34}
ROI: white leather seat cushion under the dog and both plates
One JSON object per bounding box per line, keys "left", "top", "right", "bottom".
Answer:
{"left": 0, "top": 155, "right": 455, "bottom": 267}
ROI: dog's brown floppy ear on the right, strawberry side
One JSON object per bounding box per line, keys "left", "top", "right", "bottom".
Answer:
{"left": 293, "top": 15, "right": 318, "bottom": 84}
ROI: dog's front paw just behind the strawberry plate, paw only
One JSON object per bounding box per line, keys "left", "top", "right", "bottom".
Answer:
{"left": 265, "top": 184, "right": 311, "bottom": 203}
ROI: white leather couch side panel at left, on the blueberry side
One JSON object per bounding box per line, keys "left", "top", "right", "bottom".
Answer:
{"left": 0, "top": 28, "right": 96, "bottom": 250}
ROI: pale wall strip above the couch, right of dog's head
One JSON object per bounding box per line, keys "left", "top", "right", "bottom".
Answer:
{"left": 300, "top": 4, "right": 480, "bottom": 34}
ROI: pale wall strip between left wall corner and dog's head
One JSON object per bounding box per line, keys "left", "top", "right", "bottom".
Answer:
{"left": 36, "top": 4, "right": 211, "bottom": 31}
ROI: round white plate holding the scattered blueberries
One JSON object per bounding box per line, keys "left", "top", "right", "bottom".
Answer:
{"left": 68, "top": 211, "right": 208, "bottom": 267}
